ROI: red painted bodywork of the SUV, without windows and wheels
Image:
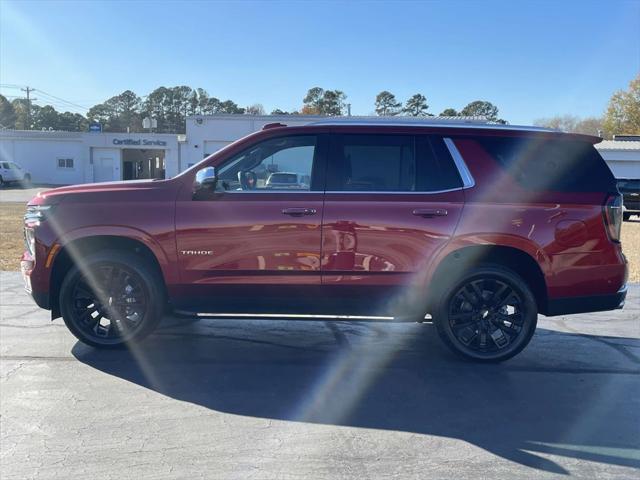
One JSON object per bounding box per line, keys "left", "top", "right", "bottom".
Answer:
{"left": 23, "top": 126, "right": 626, "bottom": 318}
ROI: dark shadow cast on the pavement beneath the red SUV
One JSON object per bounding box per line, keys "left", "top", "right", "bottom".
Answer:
{"left": 72, "top": 320, "right": 640, "bottom": 474}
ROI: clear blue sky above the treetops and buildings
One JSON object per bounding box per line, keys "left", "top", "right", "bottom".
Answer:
{"left": 0, "top": 0, "right": 640, "bottom": 124}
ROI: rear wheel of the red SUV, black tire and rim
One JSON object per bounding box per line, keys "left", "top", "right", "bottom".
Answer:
{"left": 434, "top": 265, "right": 538, "bottom": 363}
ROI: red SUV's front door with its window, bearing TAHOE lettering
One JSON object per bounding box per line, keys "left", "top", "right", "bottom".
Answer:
{"left": 176, "top": 135, "right": 326, "bottom": 310}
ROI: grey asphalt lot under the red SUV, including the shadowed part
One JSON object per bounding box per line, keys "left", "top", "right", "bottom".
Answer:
{"left": 0, "top": 272, "right": 640, "bottom": 480}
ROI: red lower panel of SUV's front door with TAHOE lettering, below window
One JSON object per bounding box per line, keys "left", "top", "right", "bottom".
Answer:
{"left": 176, "top": 193, "right": 322, "bottom": 285}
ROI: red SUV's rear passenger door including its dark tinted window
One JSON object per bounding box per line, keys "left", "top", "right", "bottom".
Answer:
{"left": 322, "top": 134, "right": 464, "bottom": 287}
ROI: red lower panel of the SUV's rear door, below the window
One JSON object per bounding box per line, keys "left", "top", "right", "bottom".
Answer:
{"left": 322, "top": 190, "right": 464, "bottom": 285}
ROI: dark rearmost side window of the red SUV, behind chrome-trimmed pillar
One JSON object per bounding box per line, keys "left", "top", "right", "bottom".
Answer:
{"left": 477, "top": 137, "right": 615, "bottom": 192}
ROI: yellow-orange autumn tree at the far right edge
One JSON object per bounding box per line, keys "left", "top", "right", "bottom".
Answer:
{"left": 603, "top": 74, "right": 640, "bottom": 135}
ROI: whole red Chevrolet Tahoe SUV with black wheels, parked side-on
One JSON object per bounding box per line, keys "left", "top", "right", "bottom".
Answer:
{"left": 22, "top": 120, "right": 627, "bottom": 361}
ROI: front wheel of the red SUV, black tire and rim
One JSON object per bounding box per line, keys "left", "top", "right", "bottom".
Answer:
{"left": 59, "top": 251, "right": 166, "bottom": 348}
